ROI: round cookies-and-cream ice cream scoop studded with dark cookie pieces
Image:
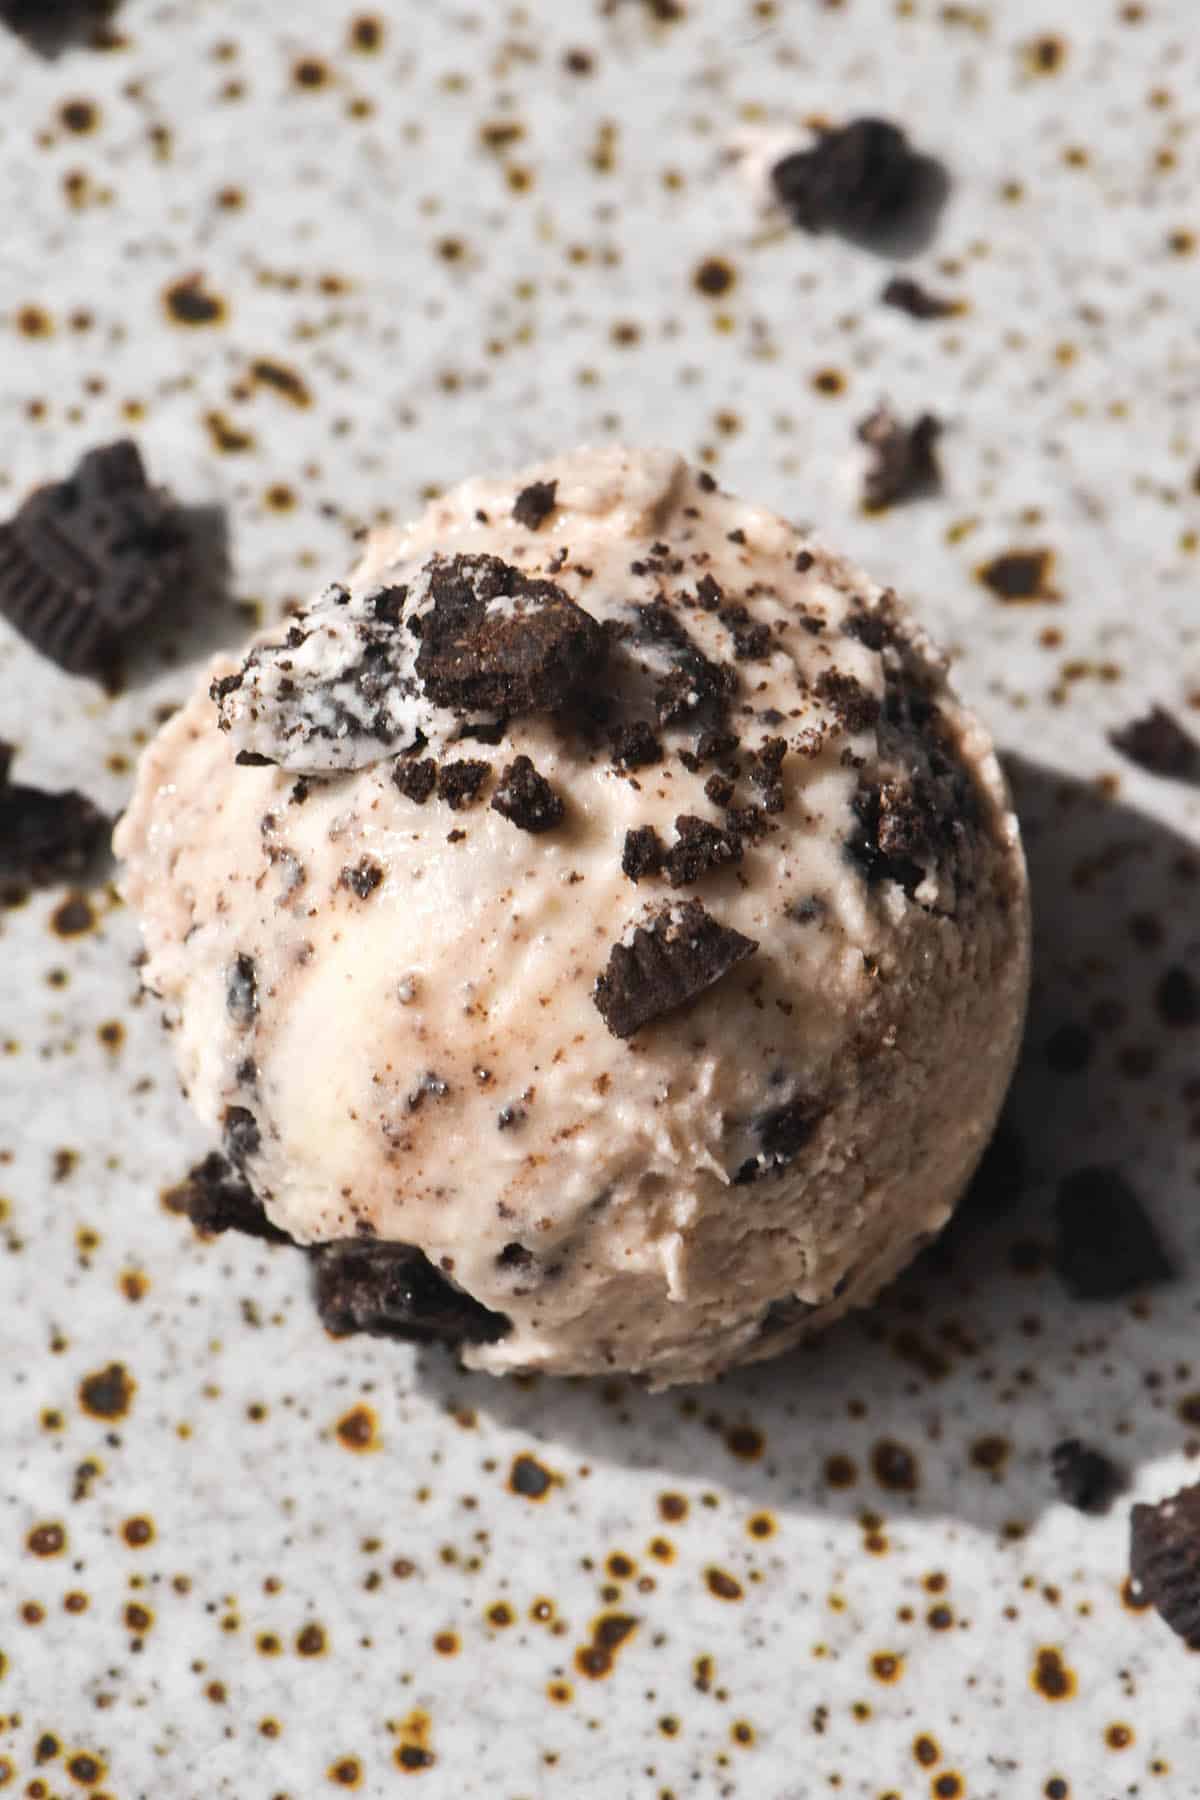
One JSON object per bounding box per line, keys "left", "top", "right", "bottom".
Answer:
{"left": 117, "top": 450, "right": 1029, "bottom": 1384}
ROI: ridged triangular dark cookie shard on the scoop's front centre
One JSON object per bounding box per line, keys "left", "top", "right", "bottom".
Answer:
{"left": 592, "top": 900, "right": 757, "bottom": 1037}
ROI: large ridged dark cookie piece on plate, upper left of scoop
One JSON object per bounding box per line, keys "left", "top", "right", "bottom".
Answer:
{"left": 0, "top": 437, "right": 187, "bottom": 675}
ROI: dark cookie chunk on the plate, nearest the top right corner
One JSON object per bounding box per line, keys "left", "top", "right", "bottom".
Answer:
{"left": 770, "top": 119, "right": 921, "bottom": 236}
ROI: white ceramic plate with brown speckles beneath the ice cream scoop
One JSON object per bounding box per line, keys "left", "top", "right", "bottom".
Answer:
{"left": 0, "top": 0, "right": 1200, "bottom": 1800}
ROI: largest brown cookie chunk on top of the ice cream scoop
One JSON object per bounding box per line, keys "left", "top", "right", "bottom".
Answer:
{"left": 408, "top": 556, "right": 608, "bottom": 715}
